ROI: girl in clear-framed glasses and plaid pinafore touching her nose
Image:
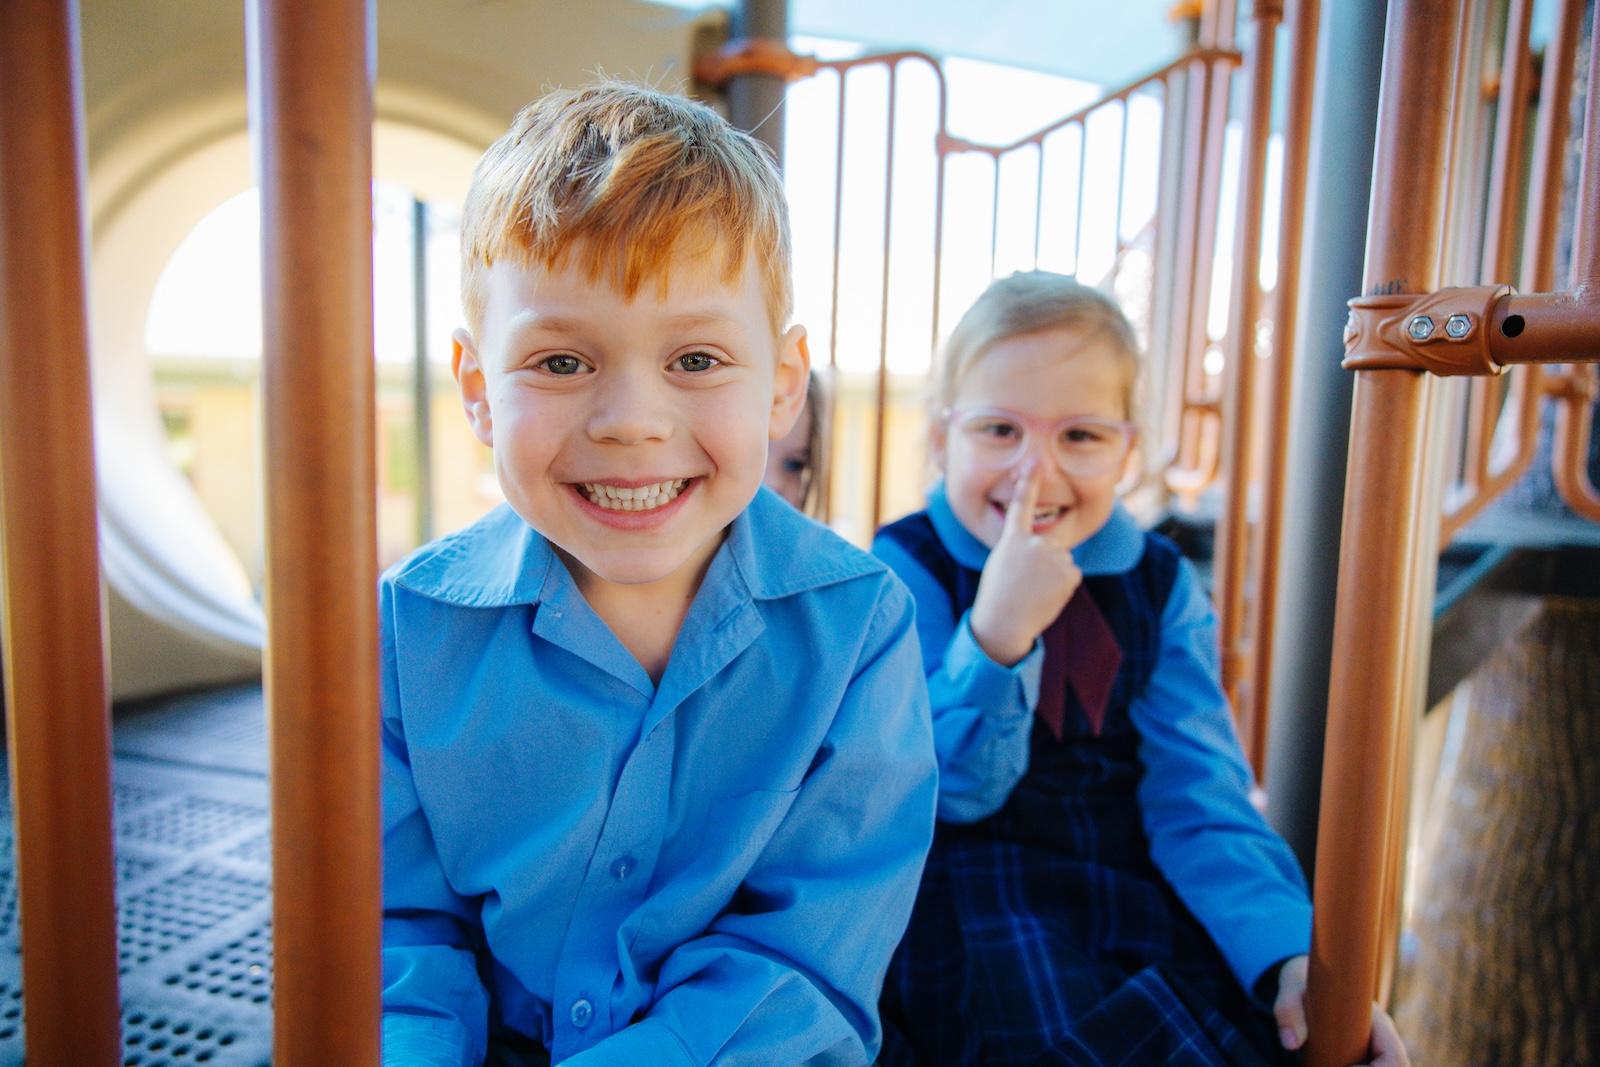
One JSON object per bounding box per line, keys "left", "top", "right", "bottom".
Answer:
{"left": 874, "top": 272, "right": 1405, "bottom": 1067}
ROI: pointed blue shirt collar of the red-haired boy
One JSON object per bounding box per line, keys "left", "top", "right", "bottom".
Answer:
{"left": 390, "top": 488, "right": 883, "bottom": 608}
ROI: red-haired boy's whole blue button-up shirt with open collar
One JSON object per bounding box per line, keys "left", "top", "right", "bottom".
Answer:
{"left": 381, "top": 490, "right": 936, "bottom": 1065}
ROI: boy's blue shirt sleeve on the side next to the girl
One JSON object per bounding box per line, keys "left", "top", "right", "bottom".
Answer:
{"left": 565, "top": 579, "right": 938, "bottom": 1067}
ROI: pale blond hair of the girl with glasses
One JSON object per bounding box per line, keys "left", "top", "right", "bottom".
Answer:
{"left": 933, "top": 270, "right": 1139, "bottom": 419}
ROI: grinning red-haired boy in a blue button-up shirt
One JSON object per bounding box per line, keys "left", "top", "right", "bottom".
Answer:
{"left": 381, "top": 85, "right": 936, "bottom": 1064}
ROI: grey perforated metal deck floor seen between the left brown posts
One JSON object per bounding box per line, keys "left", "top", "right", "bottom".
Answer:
{"left": 0, "top": 686, "right": 272, "bottom": 1067}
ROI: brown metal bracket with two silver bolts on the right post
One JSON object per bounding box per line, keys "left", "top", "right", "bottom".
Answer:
{"left": 1344, "top": 285, "right": 1512, "bottom": 378}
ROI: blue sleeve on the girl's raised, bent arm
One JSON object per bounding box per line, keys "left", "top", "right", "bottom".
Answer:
{"left": 872, "top": 537, "right": 1045, "bottom": 822}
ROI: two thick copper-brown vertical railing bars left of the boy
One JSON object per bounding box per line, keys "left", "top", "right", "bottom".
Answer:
{"left": 0, "top": 0, "right": 381, "bottom": 1064}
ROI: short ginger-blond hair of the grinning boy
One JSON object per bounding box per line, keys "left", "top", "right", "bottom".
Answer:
{"left": 461, "top": 82, "right": 794, "bottom": 334}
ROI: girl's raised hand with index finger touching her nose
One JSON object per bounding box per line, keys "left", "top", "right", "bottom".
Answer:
{"left": 971, "top": 462, "right": 1083, "bottom": 665}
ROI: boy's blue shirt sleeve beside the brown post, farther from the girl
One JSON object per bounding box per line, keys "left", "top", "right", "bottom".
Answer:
{"left": 379, "top": 579, "right": 488, "bottom": 1067}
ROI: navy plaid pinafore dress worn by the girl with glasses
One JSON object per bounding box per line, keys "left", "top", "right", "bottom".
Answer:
{"left": 878, "top": 512, "right": 1282, "bottom": 1067}
